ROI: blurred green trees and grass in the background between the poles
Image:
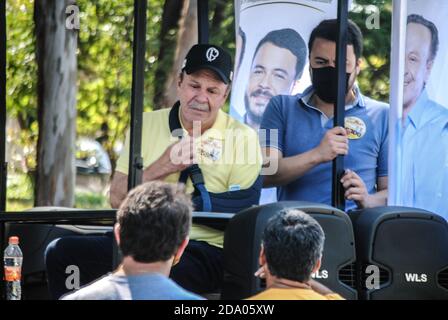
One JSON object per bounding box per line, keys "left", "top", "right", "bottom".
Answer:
{"left": 6, "top": 0, "right": 392, "bottom": 211}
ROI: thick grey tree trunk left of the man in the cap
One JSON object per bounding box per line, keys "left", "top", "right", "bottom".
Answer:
{"left": 34, "top": 0, "right": 77, "bottom": 207}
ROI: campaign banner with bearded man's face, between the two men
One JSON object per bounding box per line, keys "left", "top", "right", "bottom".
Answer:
{"left": 230, "top": 0, "right": 337, "bottom": 204}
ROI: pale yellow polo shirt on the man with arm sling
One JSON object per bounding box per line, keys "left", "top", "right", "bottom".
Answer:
{"left": 116, "top": 109, "right": 262, "bottom": 248}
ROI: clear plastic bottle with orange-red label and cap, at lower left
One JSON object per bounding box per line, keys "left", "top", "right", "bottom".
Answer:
{"left": 3, "top": 237, "right": 23, "bottom": 300}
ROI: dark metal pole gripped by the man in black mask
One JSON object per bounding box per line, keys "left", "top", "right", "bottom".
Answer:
{"left": 332, "top": 0, "right": 348, "bottom": 210}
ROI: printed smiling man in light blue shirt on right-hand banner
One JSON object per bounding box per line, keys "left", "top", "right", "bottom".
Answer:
{"left": 401, "top": 14, "right": 448, "bottom": 219}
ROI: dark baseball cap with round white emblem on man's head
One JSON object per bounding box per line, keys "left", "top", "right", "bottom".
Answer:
{"left": 182, "top": 44, "right": 233, "bottom": 84}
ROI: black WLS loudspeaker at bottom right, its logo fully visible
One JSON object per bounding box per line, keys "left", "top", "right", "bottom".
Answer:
{"left": 353, "top": 207, "right": 448, "bottom": 300}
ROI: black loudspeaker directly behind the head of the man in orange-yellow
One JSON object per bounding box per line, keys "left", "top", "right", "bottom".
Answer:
{"left": 222, "top": 201, "right": 357, "bottom": 299}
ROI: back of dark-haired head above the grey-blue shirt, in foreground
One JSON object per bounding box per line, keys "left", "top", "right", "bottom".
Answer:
{"left": 117, "top": 181, "right": 192, "bottom": 263}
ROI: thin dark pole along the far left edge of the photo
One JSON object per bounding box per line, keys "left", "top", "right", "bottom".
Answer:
{"left": 0, "top": 1, "right": 7, "bottom": 212}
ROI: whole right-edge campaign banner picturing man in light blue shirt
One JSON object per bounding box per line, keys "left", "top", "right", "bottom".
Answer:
{"left": 389, "top": 0, "right": 448, "bottom": 219}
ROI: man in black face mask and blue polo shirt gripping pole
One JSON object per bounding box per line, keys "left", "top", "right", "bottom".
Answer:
{"left": 261, "top": 20, "right": 388, "bottom": 210}
